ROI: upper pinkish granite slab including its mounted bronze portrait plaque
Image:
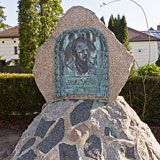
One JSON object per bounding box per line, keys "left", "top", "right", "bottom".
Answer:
{"left": 33, "top": 6, "right": 133, "bottom": 103}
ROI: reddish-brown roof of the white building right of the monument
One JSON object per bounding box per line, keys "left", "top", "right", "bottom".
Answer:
{"left": 128, "top": 27, "right": 160, "bottom": 42}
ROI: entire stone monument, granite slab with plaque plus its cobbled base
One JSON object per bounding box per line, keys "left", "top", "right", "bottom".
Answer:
{"left": 12, "top": 6, "right": 160, "bottom": 160}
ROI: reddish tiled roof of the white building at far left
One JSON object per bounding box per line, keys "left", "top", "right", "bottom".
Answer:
{"left": 0, "top": 25, "right": 19, "bottom": 38}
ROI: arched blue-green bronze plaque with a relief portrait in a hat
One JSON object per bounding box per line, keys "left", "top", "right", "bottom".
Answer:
{"left": 55, "top": 27, "right": 108, "bottom": 98}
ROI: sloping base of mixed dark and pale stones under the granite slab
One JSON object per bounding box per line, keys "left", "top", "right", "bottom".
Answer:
{"left": 12, "top": 97, "right": 160, "bottom": 160}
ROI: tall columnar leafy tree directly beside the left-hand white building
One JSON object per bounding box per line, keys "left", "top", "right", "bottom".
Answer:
{"left": 18, "top": 0, "right": 40, "bottom": 72}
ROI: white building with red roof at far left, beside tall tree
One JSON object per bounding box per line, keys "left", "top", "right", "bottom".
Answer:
{"left": 0, "top": 26, "right": 19, "bottom": 65}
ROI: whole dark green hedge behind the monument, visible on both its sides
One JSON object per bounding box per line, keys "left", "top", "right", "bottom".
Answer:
{"left": 0, "top": 74, "right": 160, "bottom": 125}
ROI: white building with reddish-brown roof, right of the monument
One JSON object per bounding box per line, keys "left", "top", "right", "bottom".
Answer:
{"left": 128, "top": 28, "right": 160, "bottom": 68}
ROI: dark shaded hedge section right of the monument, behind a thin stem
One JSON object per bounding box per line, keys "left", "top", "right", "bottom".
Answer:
{"left": 120, "top": 77, "right": 160, "bottom": 126}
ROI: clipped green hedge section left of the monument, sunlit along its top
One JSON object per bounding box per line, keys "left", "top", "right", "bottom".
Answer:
{"left": 0, "top": 73, "right": 45, "bottom": 122}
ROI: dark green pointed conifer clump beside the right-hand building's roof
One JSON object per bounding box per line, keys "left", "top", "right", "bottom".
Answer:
{"left": 108, "top": 15, "right": 129, "bottom": 50}
